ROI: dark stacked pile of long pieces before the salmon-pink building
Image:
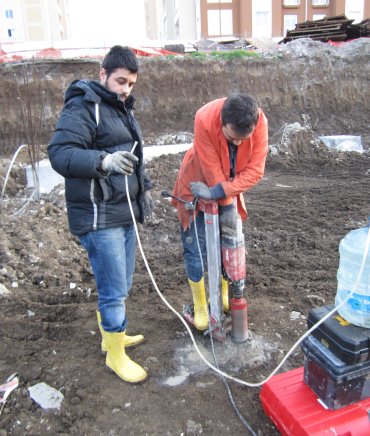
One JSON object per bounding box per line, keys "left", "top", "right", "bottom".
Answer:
{"left": 281, "top": 15, "right": 370, "bottom": 43}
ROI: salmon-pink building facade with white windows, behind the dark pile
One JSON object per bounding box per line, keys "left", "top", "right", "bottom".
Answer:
{"left": 200, "top": 0, "right": 370, "bottom": 38}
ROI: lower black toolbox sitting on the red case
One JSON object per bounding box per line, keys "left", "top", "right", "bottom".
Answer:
{"left": 301, "top": 335, "right": 370, "bottom": 410}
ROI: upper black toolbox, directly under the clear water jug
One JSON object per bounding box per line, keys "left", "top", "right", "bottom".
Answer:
{"left": 307, "top": 305, "right": 370, "bottom": 365}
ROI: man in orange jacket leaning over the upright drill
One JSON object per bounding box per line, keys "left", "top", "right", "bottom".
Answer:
{"left": 172, "top": 93, "right": 268, "bottom": 331}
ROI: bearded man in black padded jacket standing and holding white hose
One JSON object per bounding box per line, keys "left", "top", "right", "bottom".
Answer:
{"left": 48, "top": 46, "right": 153, "bottom": 383}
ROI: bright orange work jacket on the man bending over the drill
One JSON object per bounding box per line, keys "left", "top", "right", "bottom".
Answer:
{"left": 172, "top": 98, "right": 268, "bottom": 230}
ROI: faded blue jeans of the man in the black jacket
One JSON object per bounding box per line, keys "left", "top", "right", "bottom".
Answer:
{"left": 79, "top": 225, "right": 136, "bottom": 332}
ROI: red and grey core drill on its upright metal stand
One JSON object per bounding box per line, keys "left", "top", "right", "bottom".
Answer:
{"left": 162, "top": 191, "right": 248, "bottom": 343}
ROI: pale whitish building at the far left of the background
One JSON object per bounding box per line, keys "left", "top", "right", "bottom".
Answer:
{"left": 0, "top": 0, "right": 69, "bottom": 44}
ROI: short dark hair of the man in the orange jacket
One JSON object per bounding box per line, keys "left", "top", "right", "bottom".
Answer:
{"left": 221, "top": 92, "right": 259, "bottom": 136}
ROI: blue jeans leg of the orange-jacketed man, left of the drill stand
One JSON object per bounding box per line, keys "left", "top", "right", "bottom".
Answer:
{"left": 180, "top": 212, "right": 207, "bottom": 282}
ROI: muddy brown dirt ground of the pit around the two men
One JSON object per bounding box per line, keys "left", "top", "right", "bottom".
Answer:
{"left": 0, "top": 39, "right": 370, "bottom": 436}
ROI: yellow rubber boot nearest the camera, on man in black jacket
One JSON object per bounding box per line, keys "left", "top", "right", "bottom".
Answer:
{"left": 104, "top": 332, "right": 148, "bottom": 383}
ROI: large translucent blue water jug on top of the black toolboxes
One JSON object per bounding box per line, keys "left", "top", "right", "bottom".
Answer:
{"left": 335, "top": 219, "right": 370, "bottom": 328}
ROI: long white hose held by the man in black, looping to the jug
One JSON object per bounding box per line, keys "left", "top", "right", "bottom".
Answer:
{"left": 125, "top": 143, "right": 370, "bottom": 387}
